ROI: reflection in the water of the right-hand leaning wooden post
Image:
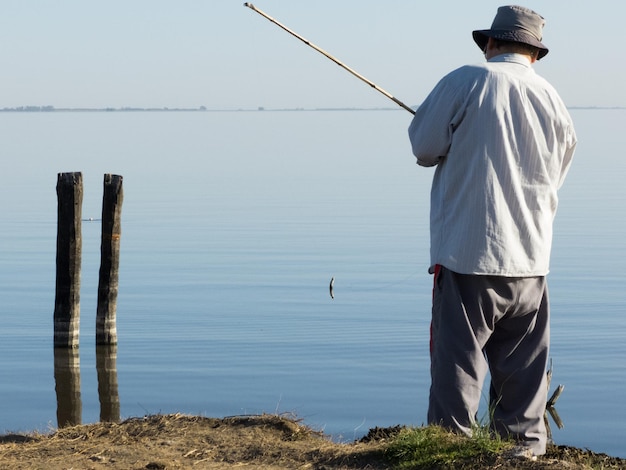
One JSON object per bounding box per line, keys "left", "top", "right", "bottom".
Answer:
{"left": 96, "top": 344, "right": 120, "bottom": 423}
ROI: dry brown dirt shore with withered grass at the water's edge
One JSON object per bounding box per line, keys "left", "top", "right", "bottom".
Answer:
{"left": 0, "top": 414, "right": 626, "bottom": 470}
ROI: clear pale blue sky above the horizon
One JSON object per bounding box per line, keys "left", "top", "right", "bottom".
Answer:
{"left": 0, "top": 0, "right": 626, "bottom": 109}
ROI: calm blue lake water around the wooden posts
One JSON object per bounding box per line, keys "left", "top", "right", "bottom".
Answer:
{"left": 0, "top": 110, "right": 626, "bottom": 457}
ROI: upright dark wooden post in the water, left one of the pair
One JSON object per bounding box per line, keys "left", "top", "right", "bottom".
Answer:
{"left": 54, "top": 172, "right": 83, "bottom": 348}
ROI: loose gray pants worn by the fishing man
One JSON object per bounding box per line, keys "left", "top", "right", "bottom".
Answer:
{"left": 428, "top": 267, "right": 550, "bottom": 455}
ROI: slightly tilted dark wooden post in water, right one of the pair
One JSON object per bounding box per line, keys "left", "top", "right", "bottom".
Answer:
{"left": 96, "top": 174, "right": 124, "bottom": 345}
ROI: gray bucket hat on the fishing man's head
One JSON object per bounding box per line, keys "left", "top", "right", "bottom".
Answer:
{"left": 472, "top": 5, "right": 548, "bottom": 60}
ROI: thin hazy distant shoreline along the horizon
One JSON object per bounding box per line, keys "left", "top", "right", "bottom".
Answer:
{"left": 0, "top": 105, "right": 626, "bottom": 113}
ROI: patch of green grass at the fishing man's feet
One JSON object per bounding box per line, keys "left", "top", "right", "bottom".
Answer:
{"left": 385, "top": 426, "right": 513, "bottom": 470}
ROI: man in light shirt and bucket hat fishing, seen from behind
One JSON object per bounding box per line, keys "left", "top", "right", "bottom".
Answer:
{"left": 409, "top": 6, "right": 576, "bottom": 456}
